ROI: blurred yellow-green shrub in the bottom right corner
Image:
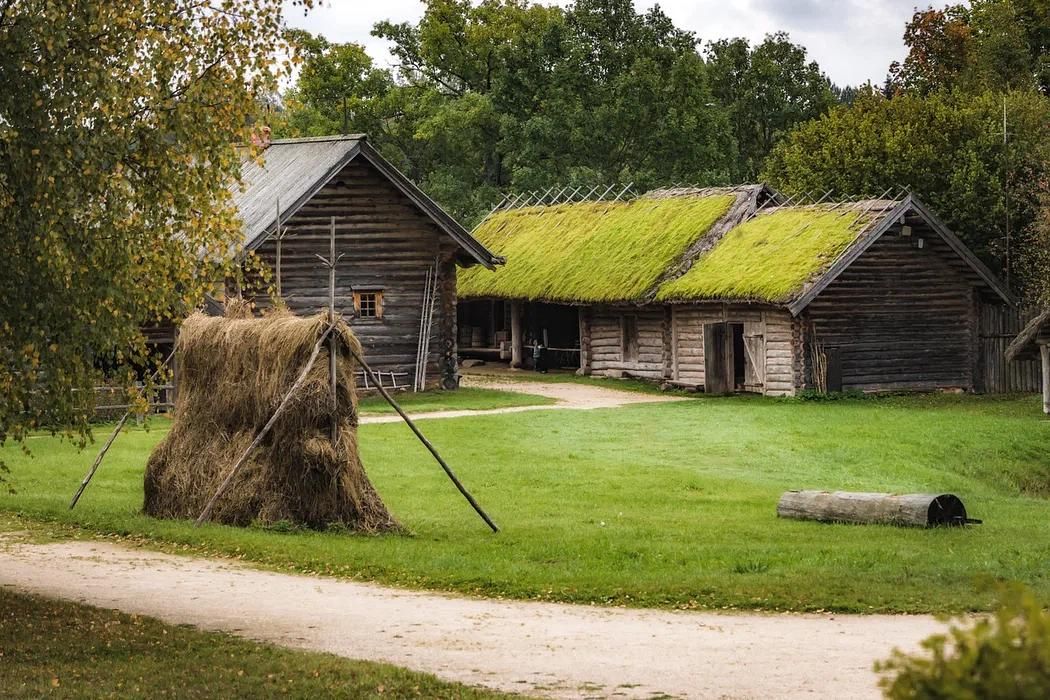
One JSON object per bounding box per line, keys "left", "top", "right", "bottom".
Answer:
{"left": 876, "top": 585, "right": 1050, "bottom": 700}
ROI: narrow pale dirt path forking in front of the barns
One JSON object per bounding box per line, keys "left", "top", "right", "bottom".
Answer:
{"left": 360, "top": 375, "right": 683, "bottom": 424}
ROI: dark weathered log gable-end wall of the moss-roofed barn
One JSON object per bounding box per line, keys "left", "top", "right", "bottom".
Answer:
{"left": 796, "top": 222, "right": 980, "bottom": 391}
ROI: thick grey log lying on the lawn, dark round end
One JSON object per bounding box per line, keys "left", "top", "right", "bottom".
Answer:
{"left": 777, "top": 491, "right": 981, "bottom": 528}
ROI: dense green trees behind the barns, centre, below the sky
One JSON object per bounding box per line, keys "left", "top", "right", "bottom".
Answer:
{"left": 278, "top": 0, "right": 835, "bottom": 221}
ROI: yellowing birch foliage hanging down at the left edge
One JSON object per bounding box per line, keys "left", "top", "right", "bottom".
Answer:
{"left": 0, "top": 0, "right": 304, "bottom": 443}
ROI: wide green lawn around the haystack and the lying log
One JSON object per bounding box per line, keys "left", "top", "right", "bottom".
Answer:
{"left": 0, "top": 396, "right": 1050, "bottom": 612}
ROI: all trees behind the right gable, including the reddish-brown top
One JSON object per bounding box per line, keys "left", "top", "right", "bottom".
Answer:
{"left": 765, "top": 0, "right": 1050, "bottom": 291}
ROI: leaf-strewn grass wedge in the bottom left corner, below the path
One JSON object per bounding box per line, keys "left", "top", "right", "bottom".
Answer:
{"left": 0, "top": 589, "right": 512, "bottom": 699}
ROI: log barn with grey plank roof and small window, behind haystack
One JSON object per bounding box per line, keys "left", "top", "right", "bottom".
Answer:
{"left": 228, "top": 135, "right": 501, "bottom": 387}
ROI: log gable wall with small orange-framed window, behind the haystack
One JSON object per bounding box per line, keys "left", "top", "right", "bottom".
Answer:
{"left": 247, "top": 161, "right": 457, "bottom": 385}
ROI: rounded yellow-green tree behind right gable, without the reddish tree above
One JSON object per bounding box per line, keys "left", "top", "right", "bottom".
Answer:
{"left": 765, "top": 91, "right": 1050, "bottom": 281}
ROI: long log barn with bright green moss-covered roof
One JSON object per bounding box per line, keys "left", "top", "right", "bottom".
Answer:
{"left": 459, "top": 186, "right": 1011, "bottom": 396}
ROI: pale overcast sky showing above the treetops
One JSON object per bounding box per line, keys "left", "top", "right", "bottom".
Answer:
{"left": 288, "top": 0, "right": 923, "bottom": 85}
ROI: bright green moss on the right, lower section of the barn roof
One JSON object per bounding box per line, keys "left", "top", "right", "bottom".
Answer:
{"left": 656, "top": 207, "right": 874, "bottom": 302}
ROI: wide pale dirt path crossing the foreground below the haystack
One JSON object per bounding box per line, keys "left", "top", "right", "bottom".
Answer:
{"left": 0, "top": 538, "right": 941, "bottom": 698}
